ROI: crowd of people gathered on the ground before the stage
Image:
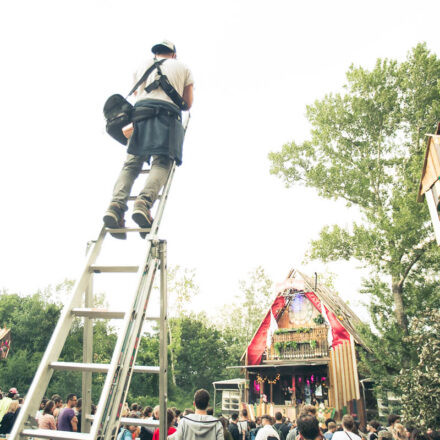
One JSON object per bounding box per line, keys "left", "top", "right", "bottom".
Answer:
{"left": 0, "top": 388, "right": 440, "bottom": 440}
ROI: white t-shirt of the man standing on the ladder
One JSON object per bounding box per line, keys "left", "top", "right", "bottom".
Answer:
{"left": 133, "top": 56, "right": 194, "bottom": 104}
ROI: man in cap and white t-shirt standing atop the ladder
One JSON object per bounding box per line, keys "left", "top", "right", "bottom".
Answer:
{"left": 103, "top": 40, "right": 194, "bottom": 239}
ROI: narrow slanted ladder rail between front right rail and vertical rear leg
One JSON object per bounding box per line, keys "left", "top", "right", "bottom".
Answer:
{"left": 102, "top": 254, "right": 159, "bottom": 439}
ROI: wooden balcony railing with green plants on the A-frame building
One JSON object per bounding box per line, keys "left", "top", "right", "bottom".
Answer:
{"left": 266, "top": 326, "right": 329, "bottom": 360}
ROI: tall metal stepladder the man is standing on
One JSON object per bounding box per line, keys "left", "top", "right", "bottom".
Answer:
{"left": 9, "top": 118, "right": 189, "bottom": 440}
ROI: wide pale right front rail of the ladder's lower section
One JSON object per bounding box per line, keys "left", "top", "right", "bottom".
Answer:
{"left": 90, "top": 253, "right": 156, "bottom": 438}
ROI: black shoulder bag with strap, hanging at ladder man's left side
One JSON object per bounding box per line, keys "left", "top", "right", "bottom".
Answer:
{"left": 103, "top": 59, "right": 165, "bottom": 145}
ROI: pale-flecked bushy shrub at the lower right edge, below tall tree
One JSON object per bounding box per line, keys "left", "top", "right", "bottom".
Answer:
{"left": 397, "top": 310, "right": 440, "bottom": 428}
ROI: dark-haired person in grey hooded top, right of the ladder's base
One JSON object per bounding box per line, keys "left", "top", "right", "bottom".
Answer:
{"left": 173, "top": 388, "right": 224, "bottom": 440}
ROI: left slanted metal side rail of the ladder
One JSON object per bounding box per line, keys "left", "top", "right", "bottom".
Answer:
{"left": 9, "top": 228, "right": 106, "bottom": 440}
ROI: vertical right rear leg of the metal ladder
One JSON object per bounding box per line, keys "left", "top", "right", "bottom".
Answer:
{"left": 159, "top": 240, "right": 168, "bottom": 440}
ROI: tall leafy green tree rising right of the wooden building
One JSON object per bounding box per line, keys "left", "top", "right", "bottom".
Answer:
{"left": 269, "top": 44, "right": 440, "bottom": 392}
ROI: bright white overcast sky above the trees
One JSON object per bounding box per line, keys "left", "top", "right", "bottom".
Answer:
{"left": 0, "top": 0, "right": 440, "bottom": 322}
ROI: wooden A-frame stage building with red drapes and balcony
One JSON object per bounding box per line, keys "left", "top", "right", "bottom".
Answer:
{"left": 237, "top": 270, "right": 365, "bottom": 422}
